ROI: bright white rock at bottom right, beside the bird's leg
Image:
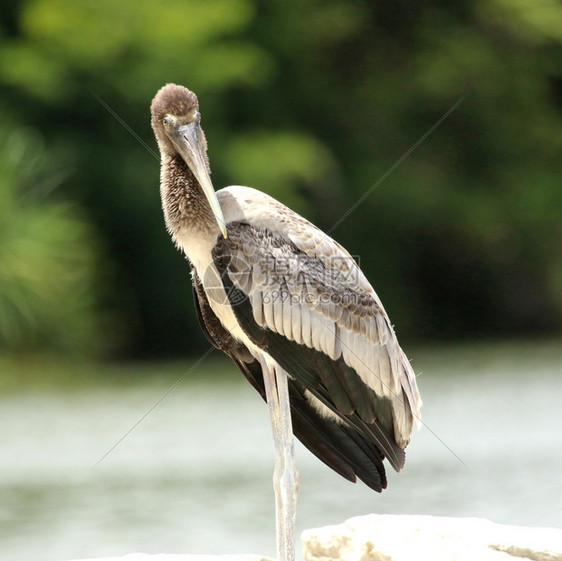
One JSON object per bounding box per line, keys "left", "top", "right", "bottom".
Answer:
{"left": 302, "top": 514, "right": 562, "bottom": 561}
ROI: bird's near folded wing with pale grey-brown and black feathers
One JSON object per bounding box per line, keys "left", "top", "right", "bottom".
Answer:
{"left": 213, "top": 219, "right": 421, "bottom": 470}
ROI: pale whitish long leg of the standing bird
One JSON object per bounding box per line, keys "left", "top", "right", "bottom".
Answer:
{"left": 262, "top": 361, "right": 297, "bottom": 561}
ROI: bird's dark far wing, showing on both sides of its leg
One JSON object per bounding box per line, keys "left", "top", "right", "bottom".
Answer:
{"left": 192, "top": 269, "right": 387, "bottom": 492}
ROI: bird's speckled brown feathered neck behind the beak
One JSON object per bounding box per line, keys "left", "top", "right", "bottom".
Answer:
{"left": 160, "top": 156, "right": 220, "bottom": 242}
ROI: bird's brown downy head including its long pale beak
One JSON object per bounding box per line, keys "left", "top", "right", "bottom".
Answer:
{"left": 150, "top": 84, "right": 226, "bottom": 238}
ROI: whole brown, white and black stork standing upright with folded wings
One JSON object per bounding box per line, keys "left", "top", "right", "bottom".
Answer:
{"left": 151, "top": 83, "right": 422, "bottom": 561}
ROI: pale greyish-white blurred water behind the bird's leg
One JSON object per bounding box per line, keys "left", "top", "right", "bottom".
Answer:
{"left": 0, "top": 343, "right": 562, "bottom": 561}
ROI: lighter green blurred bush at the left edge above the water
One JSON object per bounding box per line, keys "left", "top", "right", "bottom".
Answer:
{"left": 0, "top": 128, "right": 102, "bottom": 356}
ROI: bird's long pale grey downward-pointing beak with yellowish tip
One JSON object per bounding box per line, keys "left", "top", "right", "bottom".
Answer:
{"left": 167, "top": 122, "right": 226, "bottom": 238}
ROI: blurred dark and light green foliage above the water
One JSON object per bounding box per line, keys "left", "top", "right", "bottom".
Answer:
{"left": 0, "top": 0, "right": 562, "bottom": 357}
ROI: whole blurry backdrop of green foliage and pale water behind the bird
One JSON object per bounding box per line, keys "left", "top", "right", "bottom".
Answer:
{"left": 0, "top": 0, "right": 562, "bottom": 560}
